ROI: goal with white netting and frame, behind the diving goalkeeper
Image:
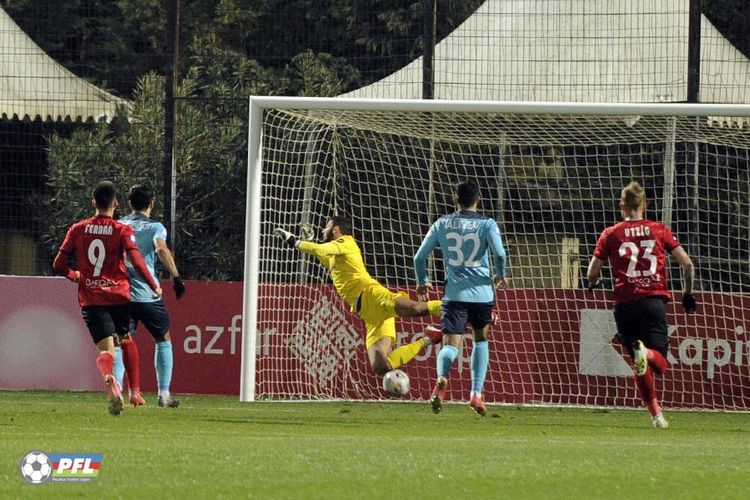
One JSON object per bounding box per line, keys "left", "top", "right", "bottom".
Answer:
{"left": 242, "top": 98, "right": 750, "bottom": 410}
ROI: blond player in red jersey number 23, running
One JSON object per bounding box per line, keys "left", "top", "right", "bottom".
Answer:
{"left": 587, "top": 182, "right": 696, "bottom": 429}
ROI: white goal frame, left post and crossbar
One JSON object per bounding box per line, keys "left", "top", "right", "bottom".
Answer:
{"left": 240, "top": 96, "right": 750, "bottom": 401}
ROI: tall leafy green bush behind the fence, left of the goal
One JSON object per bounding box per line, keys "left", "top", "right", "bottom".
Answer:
{"left": 41, "top": 37, "right": 258, "bottom": 279}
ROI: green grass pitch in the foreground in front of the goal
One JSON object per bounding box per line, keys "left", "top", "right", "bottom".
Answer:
{"left": 0, "top": 392, "right": 750, "bottom": 500}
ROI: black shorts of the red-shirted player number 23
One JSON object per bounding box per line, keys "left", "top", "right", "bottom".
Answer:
{"left": 615, "top": 297, "right": 669, "bottom": 357}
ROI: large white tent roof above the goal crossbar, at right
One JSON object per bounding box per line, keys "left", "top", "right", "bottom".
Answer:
{"left": 342, "top": 0, "right": 750, "bottom": 103}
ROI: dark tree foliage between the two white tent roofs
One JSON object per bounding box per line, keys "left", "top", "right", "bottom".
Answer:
{"left": 2, "top": 0, "right": 482, "bottom": 99}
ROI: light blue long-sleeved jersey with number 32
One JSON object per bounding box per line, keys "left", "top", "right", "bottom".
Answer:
{"left": 414, "top": 210, "right": 506, "bottom": 303}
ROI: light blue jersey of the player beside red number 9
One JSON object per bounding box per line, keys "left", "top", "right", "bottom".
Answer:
{"left": 120, "top": 213, "right": 167, "bottom": 302}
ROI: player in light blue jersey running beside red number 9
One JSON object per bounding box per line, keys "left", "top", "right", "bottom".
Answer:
{"left": 118, "top": 184, "right": 185, "bottom": 408}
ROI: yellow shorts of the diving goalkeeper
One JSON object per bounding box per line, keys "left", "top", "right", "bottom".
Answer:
{"left": 358, "top": 285, "right": 409, "bottom": 349}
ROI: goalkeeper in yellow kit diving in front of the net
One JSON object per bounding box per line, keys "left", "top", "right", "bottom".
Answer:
{"left": 274, "top": 215, "right": 443, "bottom": 375}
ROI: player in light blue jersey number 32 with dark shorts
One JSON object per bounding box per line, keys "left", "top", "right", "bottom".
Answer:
{"left": 414, "top": 181, "right": 509, "bottom": 416}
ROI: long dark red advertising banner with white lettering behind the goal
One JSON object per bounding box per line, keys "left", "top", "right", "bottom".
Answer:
{"left": 0, "top": 276, "right": 750, "bottom": 410}
